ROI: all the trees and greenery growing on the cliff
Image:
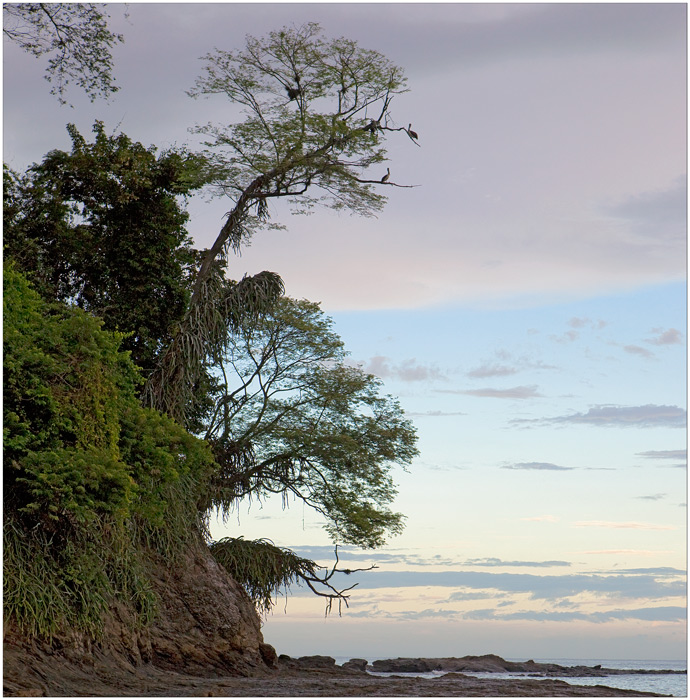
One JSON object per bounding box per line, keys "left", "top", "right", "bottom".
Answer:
{"left": 3, "top": 24, "right": 416, "bottom": 637}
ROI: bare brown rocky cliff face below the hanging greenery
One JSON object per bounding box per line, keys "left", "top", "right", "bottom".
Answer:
{"left": 3, "top": 547, "right": 275, "bottom": 696}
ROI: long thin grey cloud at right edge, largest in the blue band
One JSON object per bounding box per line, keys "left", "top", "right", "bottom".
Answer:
{"left": 510, "top": 404, "right": 687, "bottom": 428}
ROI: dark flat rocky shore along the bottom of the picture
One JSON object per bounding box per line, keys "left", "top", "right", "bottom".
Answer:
{"left": 4, "top": 654, "right": 684, "bottom": 697}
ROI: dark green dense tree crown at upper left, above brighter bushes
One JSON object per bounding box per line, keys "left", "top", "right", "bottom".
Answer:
{"left": 4, "top": 122, "right": 201, "bottom": 372}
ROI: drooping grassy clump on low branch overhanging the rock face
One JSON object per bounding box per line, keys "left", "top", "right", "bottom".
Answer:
{"left": 210, "top": 537, "right": 319, "bottom": 613}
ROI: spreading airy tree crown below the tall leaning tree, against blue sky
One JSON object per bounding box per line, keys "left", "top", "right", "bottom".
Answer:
{"left": 199, "top": 297, "right": 417, "bottom": 547}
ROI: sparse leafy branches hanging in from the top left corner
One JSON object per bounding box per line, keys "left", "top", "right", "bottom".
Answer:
{"left": 2, "top": 2, "right": 124, "bottom": 104}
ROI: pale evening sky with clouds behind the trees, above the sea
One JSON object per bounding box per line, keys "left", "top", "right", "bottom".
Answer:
{"left": 3, "top": 3, "right": 687, "bottom": 660}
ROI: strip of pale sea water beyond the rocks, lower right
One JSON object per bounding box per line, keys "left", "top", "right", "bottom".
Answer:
{"left": 336, "top": 656, "right": 688, "bottom": 698}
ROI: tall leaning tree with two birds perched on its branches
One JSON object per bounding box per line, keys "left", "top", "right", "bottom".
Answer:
{"left": 147, "top": 23, "right": 416, "bottom": 421}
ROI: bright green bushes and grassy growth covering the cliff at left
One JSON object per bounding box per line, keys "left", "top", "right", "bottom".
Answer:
{"left": 3, "top": 263, "right": 214, "bottom": 636}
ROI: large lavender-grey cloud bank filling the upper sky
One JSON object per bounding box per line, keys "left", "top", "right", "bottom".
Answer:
{"left": 5, "top": 3, "right": 685, "bottom": 310}
